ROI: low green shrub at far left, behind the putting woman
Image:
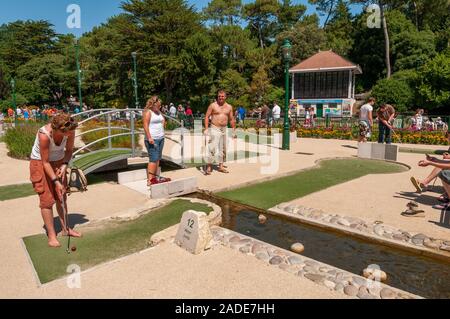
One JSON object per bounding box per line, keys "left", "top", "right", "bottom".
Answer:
{"left": 5, "top": 124, "right": 41, "bottom": 159}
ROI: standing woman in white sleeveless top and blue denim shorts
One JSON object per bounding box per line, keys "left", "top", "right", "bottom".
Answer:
{"left": 143, "top": 96, "right": 170, "bottom": 186}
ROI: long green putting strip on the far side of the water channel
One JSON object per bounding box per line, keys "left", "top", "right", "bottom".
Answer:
{"left": 217, "top": 159, "right": 407, "bottom": 209}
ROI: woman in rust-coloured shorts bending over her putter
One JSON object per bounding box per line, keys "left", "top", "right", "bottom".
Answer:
{"left": 30, "top": 113, "right": 81, "bottom": 247}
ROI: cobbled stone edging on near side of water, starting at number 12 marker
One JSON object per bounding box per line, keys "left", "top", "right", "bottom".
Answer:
{"left": 211, "top": 227, "right": 422, "bottom": 299}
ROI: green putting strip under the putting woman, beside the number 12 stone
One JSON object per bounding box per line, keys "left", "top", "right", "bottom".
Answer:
{"left": 23, "top": 200, "right": 212, "bottom": 283}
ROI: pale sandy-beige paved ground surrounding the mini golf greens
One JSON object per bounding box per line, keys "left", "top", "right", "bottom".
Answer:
{"left": 0, "top": 139, "right": 450, "bottom": 298}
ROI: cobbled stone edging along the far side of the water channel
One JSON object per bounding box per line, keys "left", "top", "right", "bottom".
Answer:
{"left": 269, "top": 203, "right": 450, "bottom": 262}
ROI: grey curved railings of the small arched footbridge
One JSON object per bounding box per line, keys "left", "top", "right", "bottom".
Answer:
{"left": 72, "top": 108, "right": 184, "bottom": 166}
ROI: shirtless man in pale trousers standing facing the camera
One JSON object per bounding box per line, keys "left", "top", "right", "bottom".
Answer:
{"left": 205, "top": 90, "right": 236, "bottom": 175}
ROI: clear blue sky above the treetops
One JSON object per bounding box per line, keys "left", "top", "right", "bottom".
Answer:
{"left": 0, "top": 0, "right": 364, "bottom": 36}
